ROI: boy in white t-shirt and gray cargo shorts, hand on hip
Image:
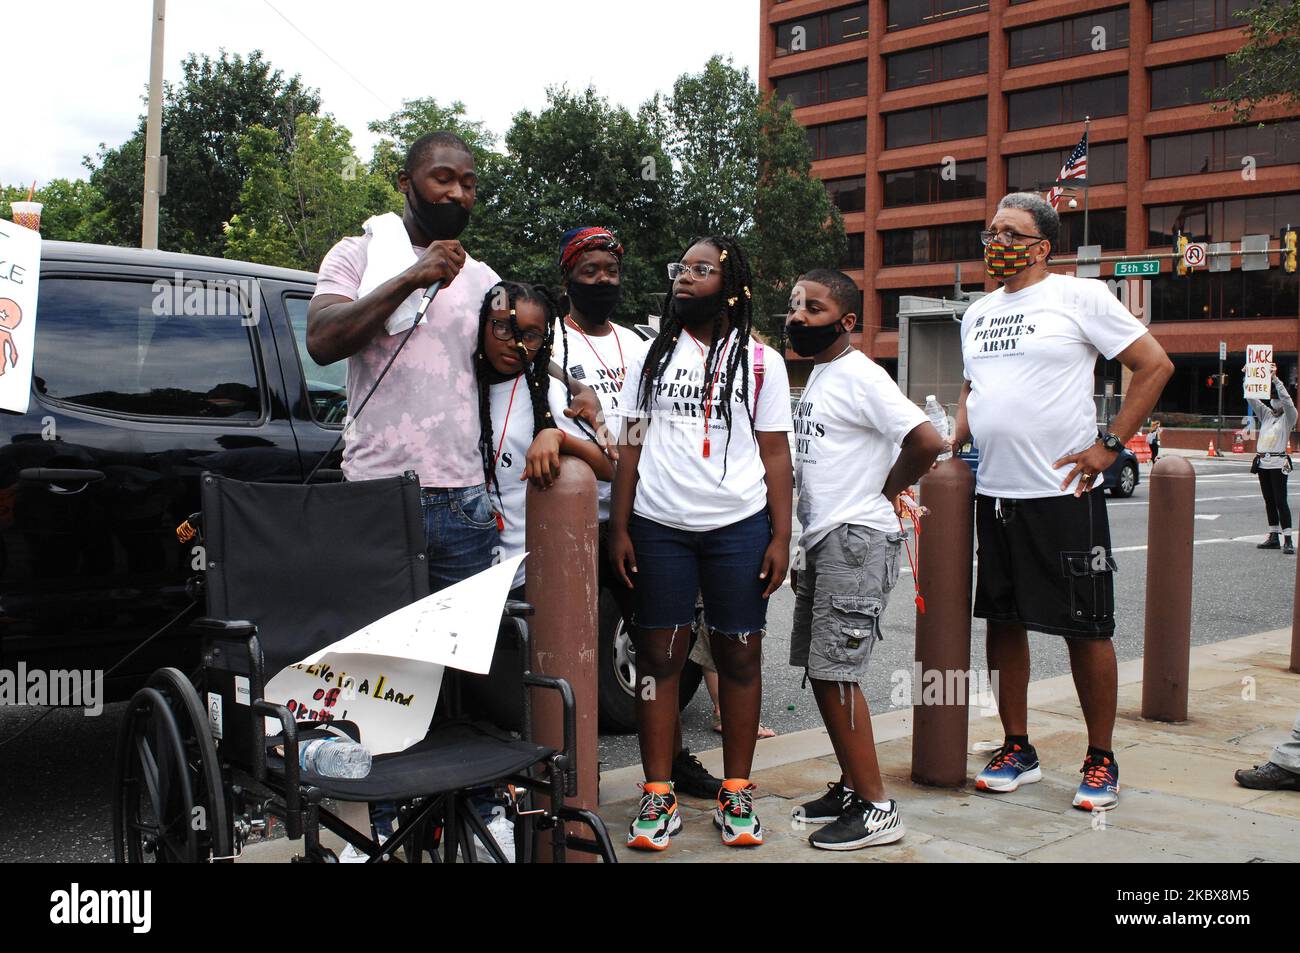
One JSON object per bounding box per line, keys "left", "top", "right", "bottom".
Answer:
{"left": 785, "top": 269, "right": 944, "bottom": 850}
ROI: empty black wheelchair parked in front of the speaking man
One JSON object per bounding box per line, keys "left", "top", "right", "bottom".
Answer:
{"left": 113, "top": 473, "right": 616, "bottom": 863}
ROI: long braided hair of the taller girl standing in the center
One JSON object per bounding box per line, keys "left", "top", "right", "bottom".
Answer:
{"left": 637, "top": 235, "right": 757, "bottom": 482}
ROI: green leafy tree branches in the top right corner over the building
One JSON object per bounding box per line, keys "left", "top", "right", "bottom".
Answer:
{"left": 1213, "top": 0, "right": 1300, "bottom": 122}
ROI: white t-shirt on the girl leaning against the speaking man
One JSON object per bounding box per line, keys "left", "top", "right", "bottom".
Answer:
{"left": 488, "top": 376, "right": 590, "bottom": 586}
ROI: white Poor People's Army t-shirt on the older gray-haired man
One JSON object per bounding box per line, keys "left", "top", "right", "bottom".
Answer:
{"left": 962, "top": 274, "right": 1147, "bottom": 499}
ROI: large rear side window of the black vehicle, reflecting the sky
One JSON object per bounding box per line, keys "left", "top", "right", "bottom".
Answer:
{"left": 33, "top": 277, "right": 263, "bottom": 420}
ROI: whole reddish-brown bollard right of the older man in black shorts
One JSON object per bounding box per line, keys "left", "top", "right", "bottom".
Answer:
{"left": 1141, "top": 456, "right": 1196, "bottom": 722}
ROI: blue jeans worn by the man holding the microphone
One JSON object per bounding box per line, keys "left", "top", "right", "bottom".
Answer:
{"left": 371, "top": 484, "right": 501, "bottom": 837}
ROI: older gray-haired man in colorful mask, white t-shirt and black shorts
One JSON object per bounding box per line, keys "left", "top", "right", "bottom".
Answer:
{"left": 953, "top": 192, "right": 1174, "bottom": 811}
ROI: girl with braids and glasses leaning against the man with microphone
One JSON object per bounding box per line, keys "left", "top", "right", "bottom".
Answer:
{"left": 475, "top": 281, "right": 614, "bottom": 598}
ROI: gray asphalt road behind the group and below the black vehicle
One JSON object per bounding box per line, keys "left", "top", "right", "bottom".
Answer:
{"left": 0, "top": 460, "right": 1300, "bottom": 862}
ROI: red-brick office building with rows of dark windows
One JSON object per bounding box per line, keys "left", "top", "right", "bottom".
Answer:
{"left": 759, "top": 0, "right": 1300, "bottom": 416}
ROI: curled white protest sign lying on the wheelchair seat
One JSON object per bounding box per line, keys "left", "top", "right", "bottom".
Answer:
{"left": 267, "top": 555, "right": 524, "bottom": 754}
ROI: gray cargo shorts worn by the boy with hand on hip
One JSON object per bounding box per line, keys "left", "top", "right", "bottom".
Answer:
{"left": 790, "top": 524, "right": 904, "bottom": 683}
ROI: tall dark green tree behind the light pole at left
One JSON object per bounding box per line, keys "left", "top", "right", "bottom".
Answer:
{"left": 85, "top": 49, "right": 320, "bottom": 255}
